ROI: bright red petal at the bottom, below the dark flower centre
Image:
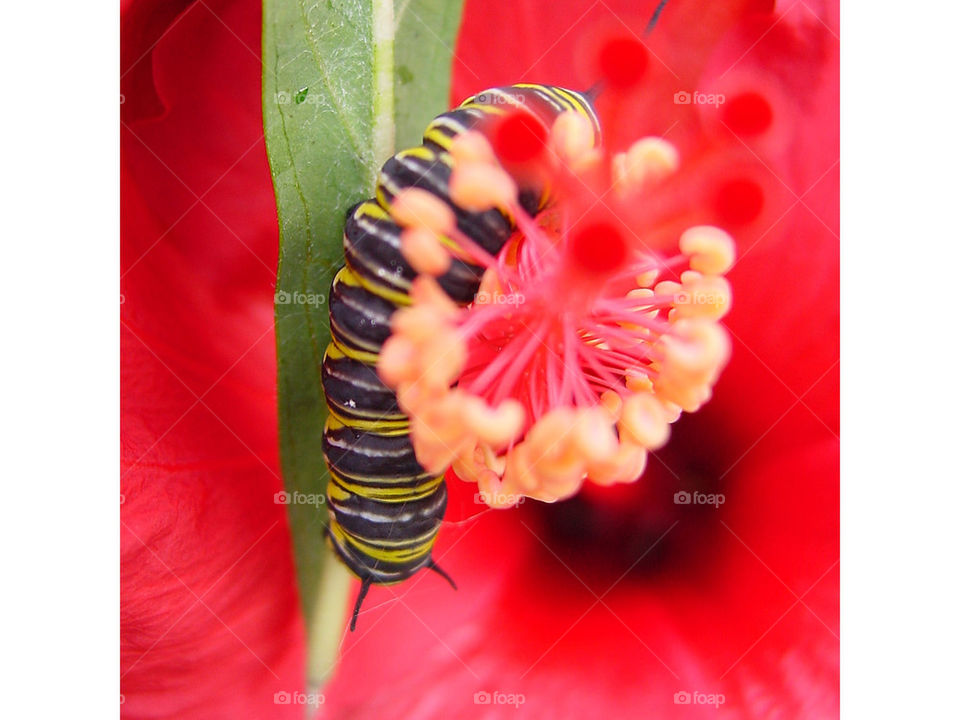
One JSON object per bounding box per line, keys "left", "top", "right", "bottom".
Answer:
{"left": 323, "top": 409, "right": 839, "bottom": 720}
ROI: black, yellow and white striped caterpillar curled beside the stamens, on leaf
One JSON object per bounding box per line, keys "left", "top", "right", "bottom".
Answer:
{"left": 322, "top": 84, "right": 599, "bottom": 630}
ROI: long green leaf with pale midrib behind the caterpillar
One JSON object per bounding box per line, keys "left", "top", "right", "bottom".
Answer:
{"left": 263, "top": 0, "right": 460, "bottom": 687}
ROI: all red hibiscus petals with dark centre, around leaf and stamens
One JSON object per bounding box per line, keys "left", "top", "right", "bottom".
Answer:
{"left": 121, "top": 0, "right": 839, "bottom": 718}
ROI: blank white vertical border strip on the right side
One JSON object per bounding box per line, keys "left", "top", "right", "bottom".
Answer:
{"left": 840, "top": 0, "right": 960, "bottom": 718}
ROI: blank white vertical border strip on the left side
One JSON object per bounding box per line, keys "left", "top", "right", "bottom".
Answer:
{"left": 0, "top": 2, "right": 120, "bottom": 717}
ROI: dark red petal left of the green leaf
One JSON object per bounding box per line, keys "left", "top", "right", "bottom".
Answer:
{"left": 121, "top": 2, "right": 303, "bottom": 718}
